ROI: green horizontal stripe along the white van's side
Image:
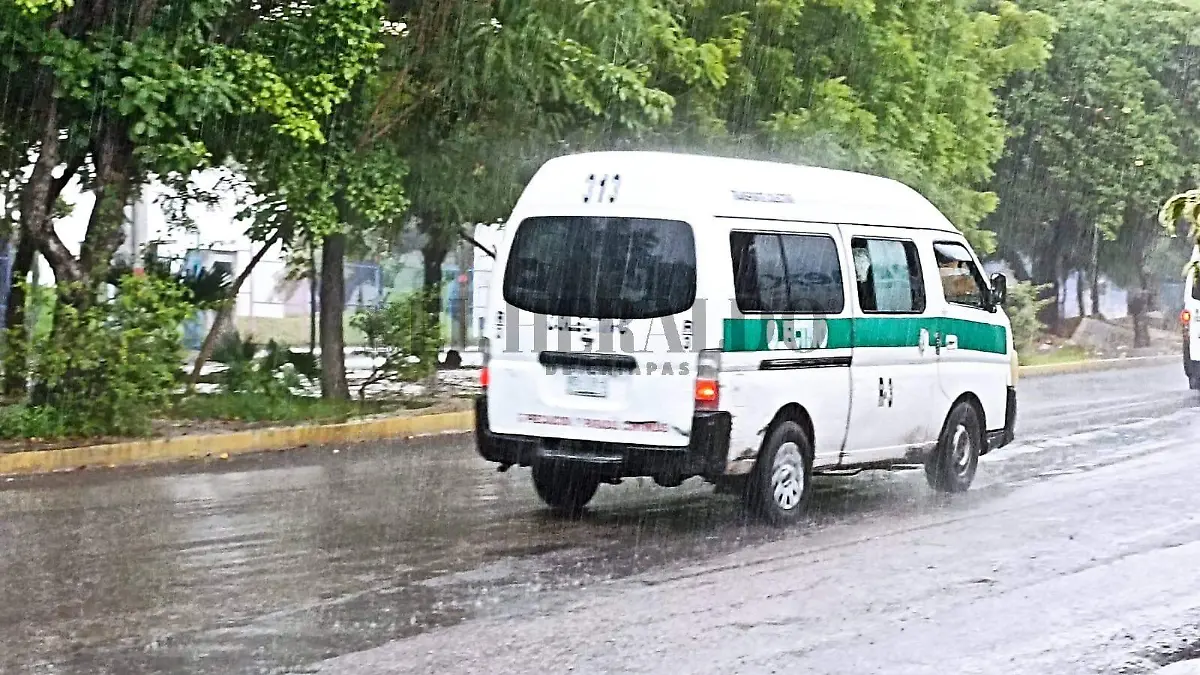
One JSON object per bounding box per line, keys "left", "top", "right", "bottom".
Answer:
{"left": 724, "top": 317, "right": 1008, "bottom": 354}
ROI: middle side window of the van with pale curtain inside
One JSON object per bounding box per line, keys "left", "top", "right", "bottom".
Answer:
{"left": 851, "top": 237, "right": 925, "bottom": 313}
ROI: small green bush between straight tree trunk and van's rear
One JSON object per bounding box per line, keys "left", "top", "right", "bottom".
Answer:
{"left": 350, "top": 293, "right": 443, "bottom": 399}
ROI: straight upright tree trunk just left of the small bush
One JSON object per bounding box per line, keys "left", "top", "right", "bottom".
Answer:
{"left": 320, "top": 233, "right": 350, "bottom": 399}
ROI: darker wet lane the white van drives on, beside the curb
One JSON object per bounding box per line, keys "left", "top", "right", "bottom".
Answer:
{"left": 0, "top": 368, "right": 1200, "bottom": 673}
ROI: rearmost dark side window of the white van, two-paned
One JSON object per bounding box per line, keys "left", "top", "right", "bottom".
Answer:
{"left": 730, "top": 232, "right": 846, "bottom": 313}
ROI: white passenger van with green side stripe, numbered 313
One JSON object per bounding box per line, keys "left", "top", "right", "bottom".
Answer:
{"left": 475, "top": 153, "right": 1016, "bottom": 524}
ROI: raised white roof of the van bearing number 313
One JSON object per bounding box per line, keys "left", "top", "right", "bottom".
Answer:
{"left": 517, "top": 151, "right": 958, "bottom": 232}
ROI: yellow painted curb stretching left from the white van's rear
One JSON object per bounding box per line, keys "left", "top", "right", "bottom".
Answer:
{"left": 0, "top": 411, "right": 475, "bottom": 476}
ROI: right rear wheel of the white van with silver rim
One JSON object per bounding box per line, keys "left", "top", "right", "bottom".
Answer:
{"left": 745, "top": 422, "right": 812, "bottom": 526}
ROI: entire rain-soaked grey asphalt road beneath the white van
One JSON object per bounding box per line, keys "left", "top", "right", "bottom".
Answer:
{"left": 7, "top": 366, "right": 1200, "bottom": 675}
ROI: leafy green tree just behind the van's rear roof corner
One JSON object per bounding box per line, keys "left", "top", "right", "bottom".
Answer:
{"left": 379, "top": 0, "right": 724, "bottom": 326}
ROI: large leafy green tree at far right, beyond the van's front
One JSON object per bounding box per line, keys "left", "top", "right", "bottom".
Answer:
{"left": 988, "top": 0, "right": 1200, "bottom": 338}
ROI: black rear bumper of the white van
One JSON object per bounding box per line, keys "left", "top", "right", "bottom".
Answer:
{"left": 475, "top": 394, "right": 733, "bottom": 479}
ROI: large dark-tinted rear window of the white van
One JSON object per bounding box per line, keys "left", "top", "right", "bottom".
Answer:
{"left": 503, "top": 216, "right": 696, "bottom": 318}
